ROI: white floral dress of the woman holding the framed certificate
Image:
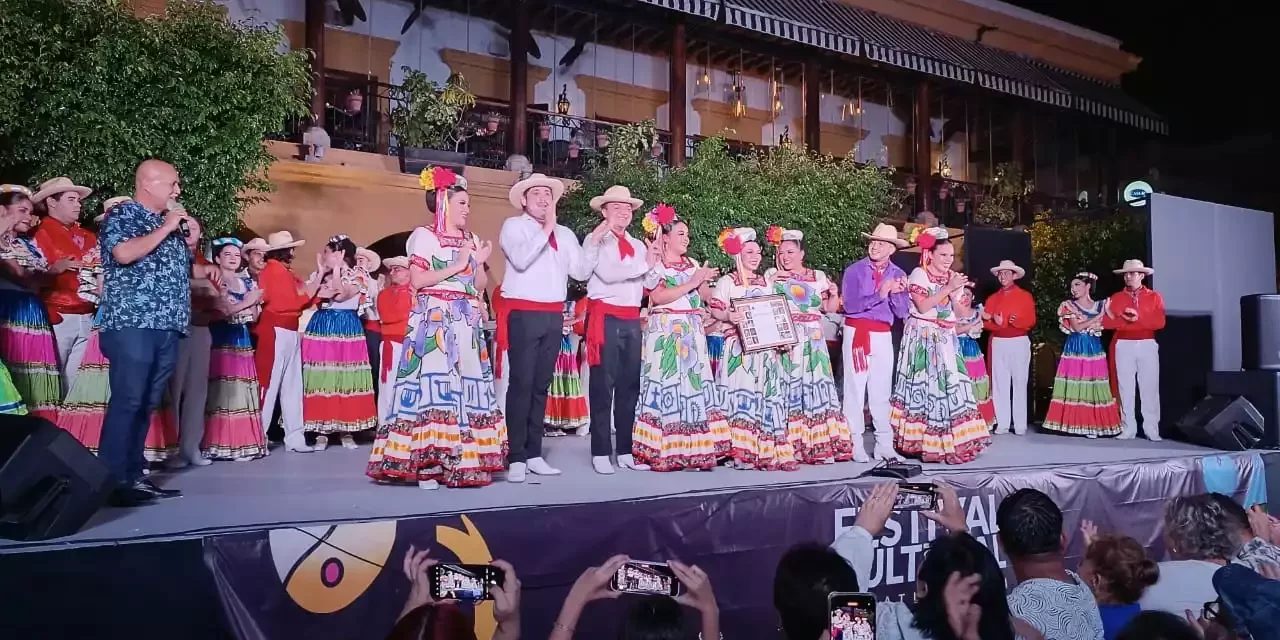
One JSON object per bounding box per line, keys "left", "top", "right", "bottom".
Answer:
{"left": 712, "top": 274, "right": 799, "bottom": 471}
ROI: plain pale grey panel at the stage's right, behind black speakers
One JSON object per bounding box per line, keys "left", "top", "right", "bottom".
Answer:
{"left": 1151, "top": 193, "right": 1276, "bottom": 371}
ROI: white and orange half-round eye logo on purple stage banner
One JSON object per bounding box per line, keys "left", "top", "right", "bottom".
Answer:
{"left": 269, "top": 520, "right": 396, "bottom": 613}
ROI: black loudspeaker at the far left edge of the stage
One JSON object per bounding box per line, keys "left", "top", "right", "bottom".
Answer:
{"left": 0, "top": 416, "right": 108, "bottom": 540}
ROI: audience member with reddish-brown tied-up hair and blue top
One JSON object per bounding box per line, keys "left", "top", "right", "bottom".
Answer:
{"left": 1080, "top": 520, "right": 1160, "bottom": 640}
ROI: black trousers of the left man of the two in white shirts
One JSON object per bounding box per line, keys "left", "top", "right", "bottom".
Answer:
{"left": 506, "top": 310, "right": 564, "bottom": 463}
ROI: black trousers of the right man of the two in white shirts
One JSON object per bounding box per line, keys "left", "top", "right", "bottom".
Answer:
{"left": 588, "top": 316, "right": 644, "bottom": 456}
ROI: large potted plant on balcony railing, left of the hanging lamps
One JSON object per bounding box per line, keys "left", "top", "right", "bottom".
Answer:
{"left": 390, "top": 67, "right": 476, "bottom": 173}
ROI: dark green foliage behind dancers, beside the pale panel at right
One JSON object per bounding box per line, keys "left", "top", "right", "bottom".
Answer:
{"left": 1030, "top": 210, "right": 1147, "bottom": 351}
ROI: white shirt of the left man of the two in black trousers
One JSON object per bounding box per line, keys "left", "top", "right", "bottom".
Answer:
{"left": 498, "top": 214, "right": 590, "bottom": 302}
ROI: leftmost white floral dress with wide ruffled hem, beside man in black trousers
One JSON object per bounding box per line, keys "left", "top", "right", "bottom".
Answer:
{"left": 366, "top": 227, "right": 508, "bottom": 486}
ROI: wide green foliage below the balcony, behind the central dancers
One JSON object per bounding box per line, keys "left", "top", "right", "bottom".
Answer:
{"left": 559, "top": 123, "right": 896, "bottom": 279}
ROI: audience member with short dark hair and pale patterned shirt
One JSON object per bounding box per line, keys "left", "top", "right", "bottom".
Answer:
{"left": 996, "top": 489, "right": 1103, "bottom": 640}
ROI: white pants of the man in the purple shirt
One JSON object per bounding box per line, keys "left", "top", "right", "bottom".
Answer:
{"left": 841, "top": 326, "right": 893, "bottom": 449}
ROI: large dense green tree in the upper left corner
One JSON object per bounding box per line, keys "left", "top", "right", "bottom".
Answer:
{"left": 0, "top": 0, "right": 310, "bottom": 234}
